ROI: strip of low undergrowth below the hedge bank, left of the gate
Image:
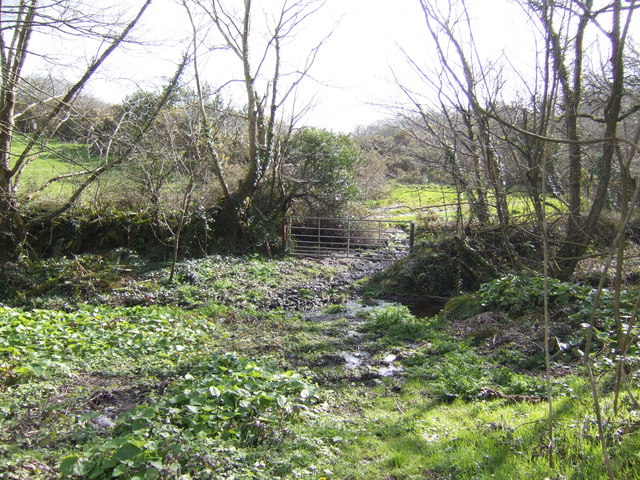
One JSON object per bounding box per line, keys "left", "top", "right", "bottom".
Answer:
{"left": 0, "top": 249, "right": 350, "bottom": 310}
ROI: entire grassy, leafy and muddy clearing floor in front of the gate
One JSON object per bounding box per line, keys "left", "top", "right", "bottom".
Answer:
{"left": 0, "top": 256, "right": 640, "bottom": 480}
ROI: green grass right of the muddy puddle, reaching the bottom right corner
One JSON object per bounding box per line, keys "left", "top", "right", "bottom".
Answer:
{"left": 296, "top": 307, "right": 640, "bottom": 480}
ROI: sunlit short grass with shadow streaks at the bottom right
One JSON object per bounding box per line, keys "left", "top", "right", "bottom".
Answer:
{"left": 314, "top": 377, "right": 640, "bottom": 480}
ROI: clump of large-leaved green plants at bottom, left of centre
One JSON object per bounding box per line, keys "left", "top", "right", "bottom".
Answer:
{"left": 60, "top": 356, "right": 314, "bottom": 479}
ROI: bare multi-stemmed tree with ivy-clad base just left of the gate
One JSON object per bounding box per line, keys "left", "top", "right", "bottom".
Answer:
{"left": 183, "top": 0, "right": 324, "bottom": 241}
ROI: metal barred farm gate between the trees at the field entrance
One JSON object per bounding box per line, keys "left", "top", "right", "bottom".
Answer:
{"left": 285, "top": 216, "right": 415, "bottom": 260}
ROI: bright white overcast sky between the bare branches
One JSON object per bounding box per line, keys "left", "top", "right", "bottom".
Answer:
{"left": 25, "top": 0, "right": 640, "bottom": 132}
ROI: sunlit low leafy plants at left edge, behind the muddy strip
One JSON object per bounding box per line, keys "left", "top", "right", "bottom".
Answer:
{"left": 0, "top": 307, "right": 215, "bottom": 378}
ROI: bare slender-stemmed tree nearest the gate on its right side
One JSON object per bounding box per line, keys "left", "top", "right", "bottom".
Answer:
{"left": 397, "top": 0, "right": 510, "bottom": 252}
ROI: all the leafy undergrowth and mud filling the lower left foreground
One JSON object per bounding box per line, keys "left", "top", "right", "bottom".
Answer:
{"left": 0, "top": 307, "right": 317, "bottom": 479}
